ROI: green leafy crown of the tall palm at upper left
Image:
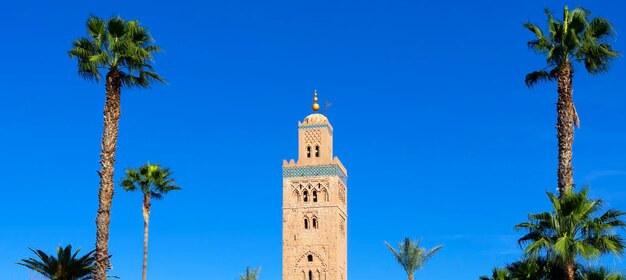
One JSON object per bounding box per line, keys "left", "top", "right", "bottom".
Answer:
{"left": 69, "top": 16, "right": 165, "bottom": 88}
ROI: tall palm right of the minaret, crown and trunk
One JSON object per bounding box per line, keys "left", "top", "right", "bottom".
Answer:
{"left": 524, "top": 7, "right": 619, "bottom": 194}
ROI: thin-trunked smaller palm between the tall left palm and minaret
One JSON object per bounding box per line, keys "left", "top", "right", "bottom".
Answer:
{"left": 120, "top": 163, "right": 180, "bottom": 280}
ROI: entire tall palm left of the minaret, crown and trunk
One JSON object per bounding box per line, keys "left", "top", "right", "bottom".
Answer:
{"left": 68, "top": 16, "right": 165, "bottom": 280}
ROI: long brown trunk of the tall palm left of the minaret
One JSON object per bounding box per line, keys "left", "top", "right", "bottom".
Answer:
{"left": 93, "top": 69, "right": 121, "bottom": 280}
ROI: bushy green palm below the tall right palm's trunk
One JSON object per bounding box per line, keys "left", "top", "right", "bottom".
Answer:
{"left": 515, "top": 187, "right": 626, "bottom": 280}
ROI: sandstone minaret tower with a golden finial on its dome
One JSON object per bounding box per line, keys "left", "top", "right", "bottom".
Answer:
{"left": 283, "top": 91, "right": 348, "bottom": 280}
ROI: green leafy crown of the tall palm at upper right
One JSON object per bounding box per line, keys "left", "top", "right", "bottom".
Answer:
{"left": 524, "top": 7, "right": 619, "bottom": 87}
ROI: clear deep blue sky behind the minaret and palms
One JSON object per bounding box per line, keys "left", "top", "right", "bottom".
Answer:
{"left": 0, "top": 0, "right": 626, "bottom": 280}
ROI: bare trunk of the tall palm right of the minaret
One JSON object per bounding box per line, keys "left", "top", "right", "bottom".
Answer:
{"left": 556, "top": 60, "right": 575, "bottom": 196}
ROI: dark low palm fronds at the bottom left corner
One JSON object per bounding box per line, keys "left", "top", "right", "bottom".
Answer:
{"left": 17, "top": 245, "right": 94, "bottom": 280}
